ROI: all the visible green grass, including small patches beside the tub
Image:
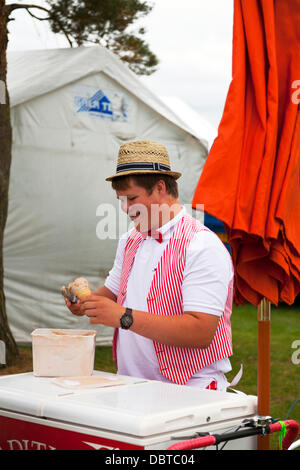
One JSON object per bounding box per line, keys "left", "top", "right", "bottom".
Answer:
{"left": 0, "top": 305, "right": 300, "bottom": 449}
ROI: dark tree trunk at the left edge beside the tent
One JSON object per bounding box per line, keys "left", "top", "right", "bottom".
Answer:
{"left": 0, "top": 0, "right": 18, "bottom": 365}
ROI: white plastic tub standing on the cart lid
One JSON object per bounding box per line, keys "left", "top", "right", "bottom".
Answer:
{"left": 31, "top": 328, "right": 96, "bottom": 377}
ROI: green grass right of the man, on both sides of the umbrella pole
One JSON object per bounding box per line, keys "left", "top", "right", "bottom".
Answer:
{"left": 228, "top": 305, "right": 300, "bottom": 421}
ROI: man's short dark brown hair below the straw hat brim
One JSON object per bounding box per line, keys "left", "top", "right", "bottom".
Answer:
{"left": 112, "top": 173, "right": 178, "bottom": 199}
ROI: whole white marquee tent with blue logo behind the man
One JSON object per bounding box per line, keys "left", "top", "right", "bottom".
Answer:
{"left": 4, "top": 46, "right": 217, "bottom": 344}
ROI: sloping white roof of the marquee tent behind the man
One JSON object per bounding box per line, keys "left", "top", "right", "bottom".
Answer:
{"left": 7, "top": 45, "right": 213, "bottom": 146}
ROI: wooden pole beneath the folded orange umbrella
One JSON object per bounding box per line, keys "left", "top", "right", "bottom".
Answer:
{"left": 257, "top": 298, "right": 271, "bottom": 450}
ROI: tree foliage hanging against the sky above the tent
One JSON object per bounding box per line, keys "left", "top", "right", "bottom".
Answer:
{"left": 47, "top": 0, "right": 158, "bottom": 75}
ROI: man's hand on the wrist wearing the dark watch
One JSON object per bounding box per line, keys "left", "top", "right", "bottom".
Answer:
{"left": 79, "top": 294, "right": 125, "bottom": 328}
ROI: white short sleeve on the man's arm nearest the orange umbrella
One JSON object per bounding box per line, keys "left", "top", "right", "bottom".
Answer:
{"left": 182, "top": 230, "right": 233, "bottom": 316}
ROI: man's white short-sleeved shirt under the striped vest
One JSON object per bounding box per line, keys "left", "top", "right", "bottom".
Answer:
{"left": 105, "top": 208, "right": 233, "bottom": 390}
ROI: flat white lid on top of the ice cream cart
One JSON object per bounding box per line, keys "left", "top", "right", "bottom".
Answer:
{"left": 0, "top": 374, "right": 257, "bottom": 437}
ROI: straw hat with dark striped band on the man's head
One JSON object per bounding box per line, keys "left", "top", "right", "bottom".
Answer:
{"left": 106, "top": 140, "right": 181, "bottom": 181}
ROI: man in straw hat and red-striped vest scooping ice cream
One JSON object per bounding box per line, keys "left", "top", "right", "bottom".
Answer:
{"left": 67, "top": 141, "right": 233, "bottom": 390}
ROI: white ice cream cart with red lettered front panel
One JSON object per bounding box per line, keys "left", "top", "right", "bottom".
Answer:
{"left": 0, "top": 371, "right": 257, "bottom": 450}
